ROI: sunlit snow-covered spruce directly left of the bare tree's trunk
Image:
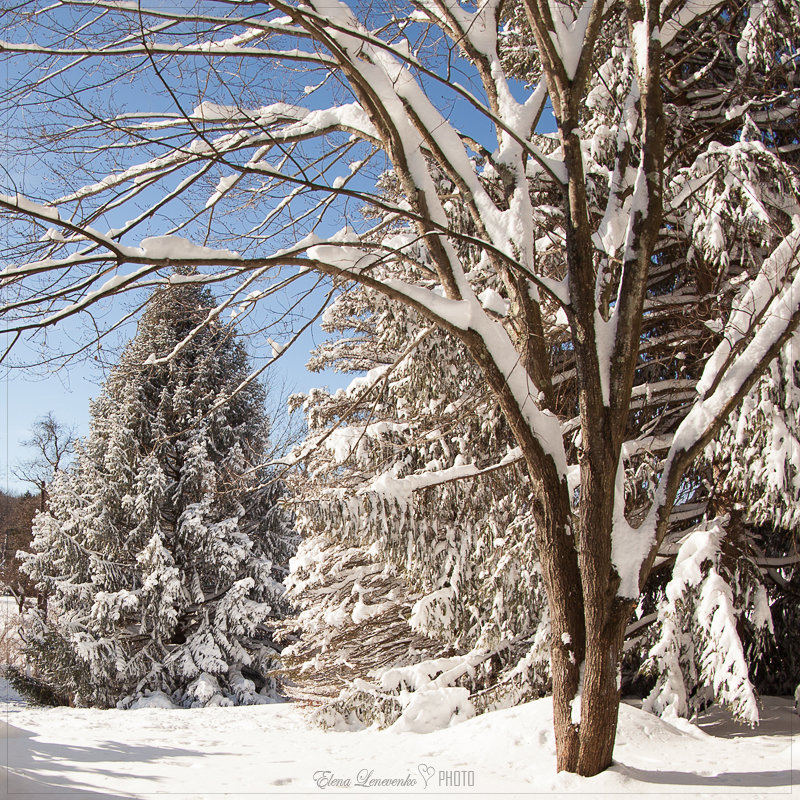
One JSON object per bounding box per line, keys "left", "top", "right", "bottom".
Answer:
{"left": 289, "top": 288, "right": 550, "bottom": 724}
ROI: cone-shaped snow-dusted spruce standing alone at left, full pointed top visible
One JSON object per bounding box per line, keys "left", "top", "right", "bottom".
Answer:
{"left": 18, "top": 287, "right": 292, "bottom": 706}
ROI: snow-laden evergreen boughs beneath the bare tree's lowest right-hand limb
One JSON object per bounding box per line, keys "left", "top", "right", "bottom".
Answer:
{"left": 645, "top": 334, "right": 800, "bottom": 712}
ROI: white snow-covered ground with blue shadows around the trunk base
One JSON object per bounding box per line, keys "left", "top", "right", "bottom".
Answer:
{"left": 0, "top": 686, "right": 800, "bottom": 800}
